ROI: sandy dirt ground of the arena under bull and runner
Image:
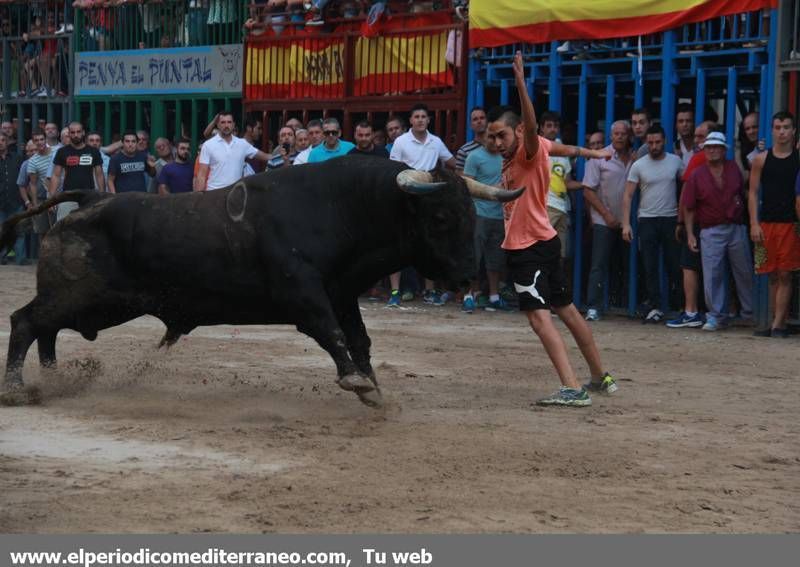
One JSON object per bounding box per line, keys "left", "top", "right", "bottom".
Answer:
{"left": 0, "top": 266, "right": 800, "bottom": 533}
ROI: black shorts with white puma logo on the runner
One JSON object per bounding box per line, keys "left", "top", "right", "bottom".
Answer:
{"left": 506, "top": 236, "right": 572, "bottom": 311}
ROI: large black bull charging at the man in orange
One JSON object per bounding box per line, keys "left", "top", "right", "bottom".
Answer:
{"left": 0, "top": 156, "right": 520, "bottom": 405}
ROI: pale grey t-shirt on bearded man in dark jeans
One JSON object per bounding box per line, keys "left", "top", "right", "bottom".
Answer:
{"left": 628, "top": 153, "right": 684, "bottom": 218}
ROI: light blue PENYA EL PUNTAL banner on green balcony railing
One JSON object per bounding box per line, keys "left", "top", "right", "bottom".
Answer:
{"left": 75, "top": 44, "right": 244, "bottom": 96}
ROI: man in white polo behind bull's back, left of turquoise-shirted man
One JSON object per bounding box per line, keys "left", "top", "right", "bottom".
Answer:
{"left": 194, "top": 112, "right": 270, "bottom": 191}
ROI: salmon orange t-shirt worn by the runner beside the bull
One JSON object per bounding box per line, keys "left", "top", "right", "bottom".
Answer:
{"left": 502, "top": 136, "right": 557, "bottom": 250}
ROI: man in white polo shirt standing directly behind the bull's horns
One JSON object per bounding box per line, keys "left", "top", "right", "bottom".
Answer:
{"left": 389, "top": 104, "right": 456, "bottom": 307}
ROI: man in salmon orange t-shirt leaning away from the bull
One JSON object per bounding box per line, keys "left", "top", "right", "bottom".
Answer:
{"left": 487, "top": 52, "right": 617, "bottom": 406}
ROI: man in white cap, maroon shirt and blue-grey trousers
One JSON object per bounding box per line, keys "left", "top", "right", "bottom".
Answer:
{"left": 681, "top": 132, "right": 753, "bottom": 331}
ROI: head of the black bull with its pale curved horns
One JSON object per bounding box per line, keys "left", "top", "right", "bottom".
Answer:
{"left": 397, "top": 169, "right": 524, "bottom": 287}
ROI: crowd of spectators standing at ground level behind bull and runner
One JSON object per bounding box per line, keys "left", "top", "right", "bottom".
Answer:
{"left": 0, "top": 98, "right": 800, "bottom": 337}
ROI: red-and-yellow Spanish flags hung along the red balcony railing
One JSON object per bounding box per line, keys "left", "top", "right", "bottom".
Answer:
{"left": 244, "top": 14, "right": 460, "bottom": 100}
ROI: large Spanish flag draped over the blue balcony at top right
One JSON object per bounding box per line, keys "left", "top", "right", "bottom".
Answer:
{"left": 469, "top": 0, "right": 777, "bottom": 48}
